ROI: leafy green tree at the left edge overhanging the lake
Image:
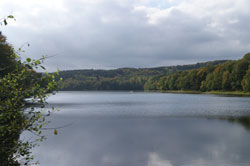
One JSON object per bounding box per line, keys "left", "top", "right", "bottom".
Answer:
{"left": 0, "top": 16, "right": 58, "bottom": 166}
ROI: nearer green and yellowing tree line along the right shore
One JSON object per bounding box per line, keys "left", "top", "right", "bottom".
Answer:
{"left": 144, "top": 53, "right": 250, "bottom": 92}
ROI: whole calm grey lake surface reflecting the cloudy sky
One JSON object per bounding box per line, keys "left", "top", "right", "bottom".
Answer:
{"left": 24, "top": 92, "right": 250, "bottom": 166}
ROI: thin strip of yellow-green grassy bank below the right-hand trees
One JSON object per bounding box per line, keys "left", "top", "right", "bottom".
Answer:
{"left": 162, "top": 90, "right": 250, "bottom": 96}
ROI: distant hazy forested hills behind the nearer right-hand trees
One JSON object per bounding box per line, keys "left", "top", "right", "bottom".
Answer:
{"left": 58, "top": 60, "right": 226, "bottom": 90}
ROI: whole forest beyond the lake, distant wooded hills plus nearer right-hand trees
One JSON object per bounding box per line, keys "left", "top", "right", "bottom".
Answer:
{"left": 57, "top": 53, "right": 250, "bottom": 92}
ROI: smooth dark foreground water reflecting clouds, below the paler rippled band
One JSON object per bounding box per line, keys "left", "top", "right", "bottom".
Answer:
{"left": 31, "top": 117, "right": 250, "bottom": 166}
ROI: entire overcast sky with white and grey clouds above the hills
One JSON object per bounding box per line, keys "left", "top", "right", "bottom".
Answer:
{"left": 0, "top": 0, "right": 250, "bottom": 71}
